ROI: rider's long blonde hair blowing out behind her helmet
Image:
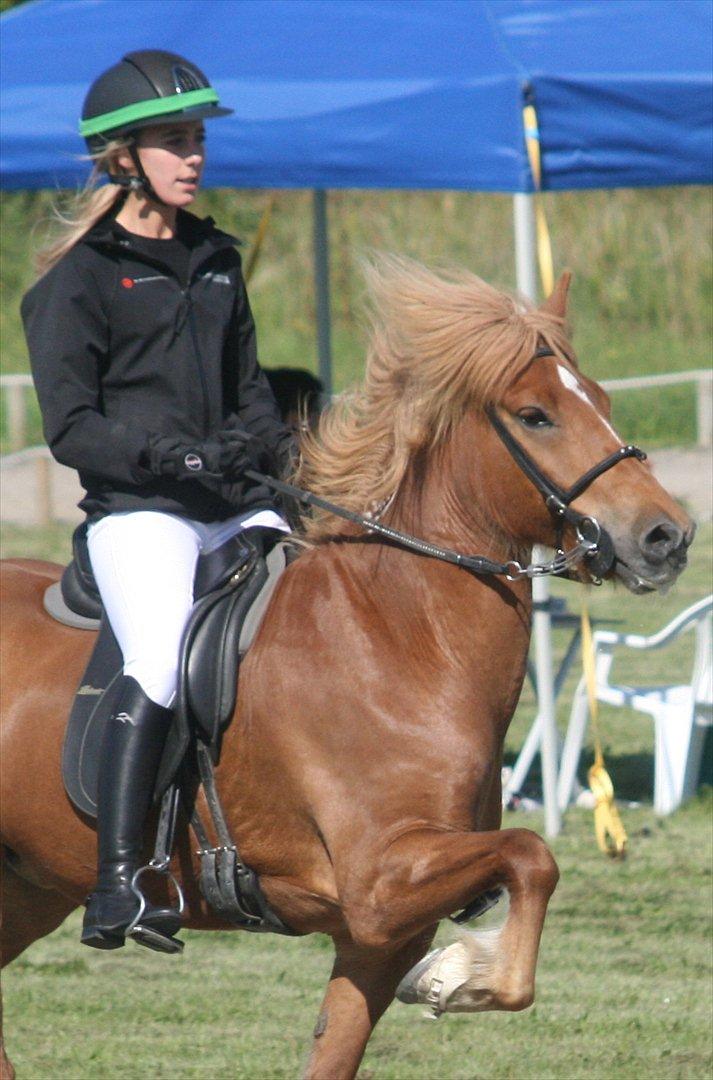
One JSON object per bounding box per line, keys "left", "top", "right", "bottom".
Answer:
{"left": 35, "top": 139, "right": 131, "bottom": 278}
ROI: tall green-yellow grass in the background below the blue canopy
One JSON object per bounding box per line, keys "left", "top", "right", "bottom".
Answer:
{"left": 0, "top": 188, "right": 712, "bottom": 445}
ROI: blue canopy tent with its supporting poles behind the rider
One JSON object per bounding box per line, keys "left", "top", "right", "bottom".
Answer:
{"left": 0, "top": 0, "right": 713, "bottom": 833}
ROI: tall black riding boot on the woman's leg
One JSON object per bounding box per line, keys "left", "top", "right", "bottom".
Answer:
{"left": 82, "top": 676, "right": 180, "bottom": 951}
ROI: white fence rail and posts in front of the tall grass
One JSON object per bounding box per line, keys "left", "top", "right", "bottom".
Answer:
{"left": 0, "top": 368, "right": 713, "bottom": 450}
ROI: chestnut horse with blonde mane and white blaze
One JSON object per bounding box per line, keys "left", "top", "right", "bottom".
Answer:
{"left": 2, "top": 258, "right": 692, "bottom": 1080}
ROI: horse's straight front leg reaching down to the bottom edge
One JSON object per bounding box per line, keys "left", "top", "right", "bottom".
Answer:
{"left": 305, "top": 926, "right": 435, "bottom": 1080}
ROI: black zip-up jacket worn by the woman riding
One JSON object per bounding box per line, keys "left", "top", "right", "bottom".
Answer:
{"left": 22, "top": 211, "right": 288, "bottom": 521}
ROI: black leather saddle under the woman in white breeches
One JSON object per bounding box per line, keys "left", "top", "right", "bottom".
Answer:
{"left": 52, "top": 525, "right": 292, "bottom": 818}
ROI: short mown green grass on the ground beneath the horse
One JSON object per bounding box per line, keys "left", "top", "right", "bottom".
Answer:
{"left": 3, "top": 525, "right": 713, "bottom": 1080}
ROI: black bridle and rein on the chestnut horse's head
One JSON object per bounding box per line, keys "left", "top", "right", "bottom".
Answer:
{"left": 245, "top": 349, "right": 646, "bottom": 584}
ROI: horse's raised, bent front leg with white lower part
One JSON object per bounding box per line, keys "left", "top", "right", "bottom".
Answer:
{"left": 340, "top": 828, "right": 559, "bottom": 1012}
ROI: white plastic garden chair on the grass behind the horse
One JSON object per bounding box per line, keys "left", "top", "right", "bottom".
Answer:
{"left": 557, "top": 596, "right": 713, "bottom": 814}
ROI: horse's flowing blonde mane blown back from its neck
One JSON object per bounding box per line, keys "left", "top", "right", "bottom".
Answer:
{"left": 298, "top": 255, "right": 568, "bottom": 541}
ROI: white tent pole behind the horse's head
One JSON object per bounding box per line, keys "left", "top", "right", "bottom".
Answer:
{"left": 513, "top": 193, "right": 562, "bottom": 836}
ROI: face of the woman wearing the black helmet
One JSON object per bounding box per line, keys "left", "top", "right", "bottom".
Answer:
{"left": 120, "top": 120, "right": 205, "bottom": 206}
